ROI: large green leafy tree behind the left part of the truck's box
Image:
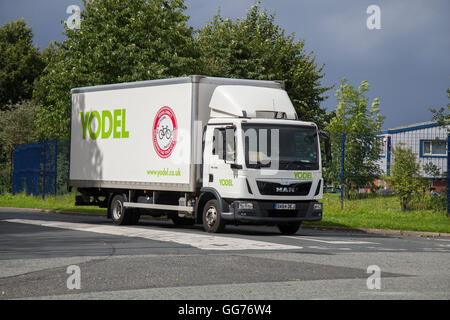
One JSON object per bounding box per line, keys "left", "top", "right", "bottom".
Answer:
{"left": 34, "top": 0, "right": 197, "bottom": 139}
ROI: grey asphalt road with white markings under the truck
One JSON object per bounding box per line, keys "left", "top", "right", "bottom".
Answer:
{"left": 0, "top": 208, "right": 450, "bottom": 300}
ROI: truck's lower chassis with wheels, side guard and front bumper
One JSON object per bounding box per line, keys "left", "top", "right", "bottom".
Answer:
{"left": 75, "top": 188, "right": 322, "bottom": 234}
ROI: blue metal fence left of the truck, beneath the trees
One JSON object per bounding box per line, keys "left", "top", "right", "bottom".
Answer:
{"left": 13, "top": 140, "right": 69, "bottom": 198}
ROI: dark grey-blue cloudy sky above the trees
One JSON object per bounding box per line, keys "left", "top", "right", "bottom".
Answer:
{"left": 0, "top": 0, "right": 450, "bottom": 129}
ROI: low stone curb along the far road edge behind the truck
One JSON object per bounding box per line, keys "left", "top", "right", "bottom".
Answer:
{"left": 0, "top": 207, "right": 450, "bottom": 239}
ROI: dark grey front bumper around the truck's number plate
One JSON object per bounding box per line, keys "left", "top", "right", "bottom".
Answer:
{"left": 221, "top": 200, "right": 322, "bottom": 225}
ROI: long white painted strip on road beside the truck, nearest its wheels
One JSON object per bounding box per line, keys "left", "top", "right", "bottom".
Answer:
{"left": 3, "top": 219, "right": 302, "bottom": 250}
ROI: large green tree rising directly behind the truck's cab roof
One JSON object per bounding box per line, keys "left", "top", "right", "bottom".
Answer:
{"left": 196, "top": 2, "right": 330, "bottom": 128}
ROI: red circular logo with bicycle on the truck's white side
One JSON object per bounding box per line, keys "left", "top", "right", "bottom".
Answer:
{"left": 152, "top": 106, "right": 178, "bottom": 158}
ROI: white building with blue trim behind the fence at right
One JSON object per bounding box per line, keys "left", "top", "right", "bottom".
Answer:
{"left": 379, "top": 121, "right": 450, "bottom": 192}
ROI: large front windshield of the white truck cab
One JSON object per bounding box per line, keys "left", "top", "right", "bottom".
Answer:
{"left": 242, "top": 124, "right": 319, "bottom": 170}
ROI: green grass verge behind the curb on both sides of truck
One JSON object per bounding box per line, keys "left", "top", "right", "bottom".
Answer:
{"left": 0, "top": 193, "right": 450, "bottom": 233}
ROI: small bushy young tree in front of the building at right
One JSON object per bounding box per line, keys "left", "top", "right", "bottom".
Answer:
{"left": 389, "top": 145, "right": 423, "bottom": 211}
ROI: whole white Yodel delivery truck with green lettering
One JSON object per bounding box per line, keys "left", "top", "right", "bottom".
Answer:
{"left": 68, "top": 76, "right": 329, "bottom": 234}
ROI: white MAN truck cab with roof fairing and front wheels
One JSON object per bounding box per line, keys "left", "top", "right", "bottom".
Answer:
{"left": 197, "top": 86, "right": 323, "bottom": 234}
